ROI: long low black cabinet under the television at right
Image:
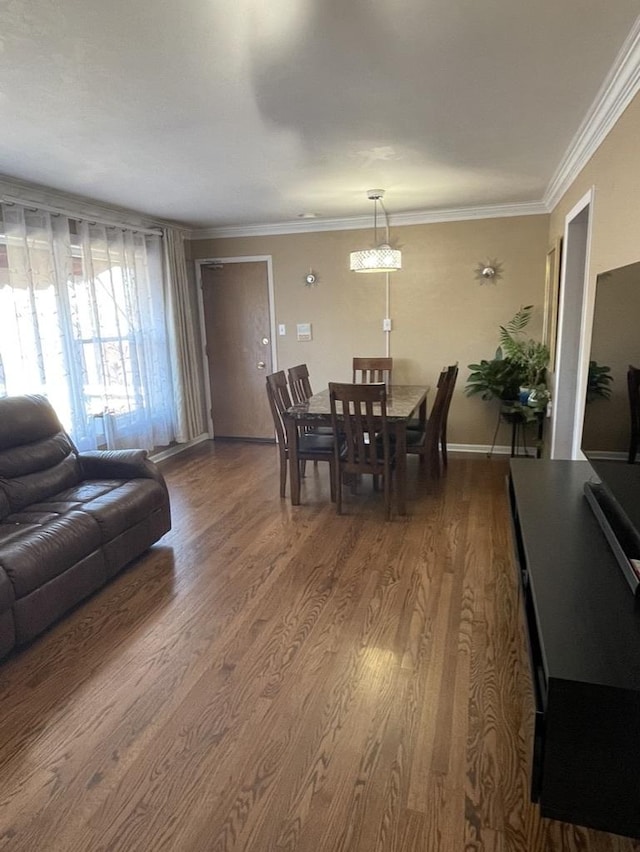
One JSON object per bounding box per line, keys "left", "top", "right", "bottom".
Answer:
{"left": 508, "top": 459, "right": 640, "bottom": 837}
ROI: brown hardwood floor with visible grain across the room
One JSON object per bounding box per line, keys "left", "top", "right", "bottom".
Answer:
{"left": 0, "top": 443, "right": 640, "bottom": 852}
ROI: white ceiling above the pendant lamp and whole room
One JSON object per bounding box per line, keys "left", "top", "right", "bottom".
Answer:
{"left": 0, "top": 0, "right": 639, "bottom": 228}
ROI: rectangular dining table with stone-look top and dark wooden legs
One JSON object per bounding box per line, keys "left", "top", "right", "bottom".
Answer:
{"left": 285, "top": 385, "right": 429, "bottom": 515}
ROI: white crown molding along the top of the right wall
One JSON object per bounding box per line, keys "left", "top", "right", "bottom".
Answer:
{"left": 543, "top": 16, "right": 640, "bottom": 211}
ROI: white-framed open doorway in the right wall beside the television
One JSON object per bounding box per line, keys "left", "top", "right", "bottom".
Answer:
{"left": 550, "top": 186, "right": 595, "bottom": 459}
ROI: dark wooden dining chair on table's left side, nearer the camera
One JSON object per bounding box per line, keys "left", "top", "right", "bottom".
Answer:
{"left": 266, "top": 370, "right": 336, "bottom": 502}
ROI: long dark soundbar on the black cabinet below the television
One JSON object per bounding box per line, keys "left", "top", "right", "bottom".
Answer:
{"left": 584, "top": 480, "right": 640, "bottom": 595}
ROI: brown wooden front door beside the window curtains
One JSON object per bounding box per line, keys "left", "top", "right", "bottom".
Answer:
{"left": 202, "top": 261, "right": 274, "bottom": 440}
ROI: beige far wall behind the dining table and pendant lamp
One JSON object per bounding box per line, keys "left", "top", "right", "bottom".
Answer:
{"left": 190, "top": 215, "right": 549, "bottom": 446}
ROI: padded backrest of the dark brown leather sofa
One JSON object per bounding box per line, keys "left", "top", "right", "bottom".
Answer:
{"left": 0, "top": 395, "right": 80, "bottom": 518}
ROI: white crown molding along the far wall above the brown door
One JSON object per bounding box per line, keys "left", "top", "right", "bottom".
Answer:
{"left": 188, "top": 201, "right": 548, "bottom": 240}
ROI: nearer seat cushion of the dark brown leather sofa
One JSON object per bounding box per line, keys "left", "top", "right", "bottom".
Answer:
{"left": 0, "top": 510, "right": 101, "bottom": 598}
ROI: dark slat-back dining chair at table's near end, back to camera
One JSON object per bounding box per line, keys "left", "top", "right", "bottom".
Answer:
{"left": 329, "top": 382, "right": 394, "bottom": 520}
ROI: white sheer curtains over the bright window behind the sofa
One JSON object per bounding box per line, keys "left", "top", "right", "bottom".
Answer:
{"left": 0, "top": 205, "right": 175, "bottom": 449}
